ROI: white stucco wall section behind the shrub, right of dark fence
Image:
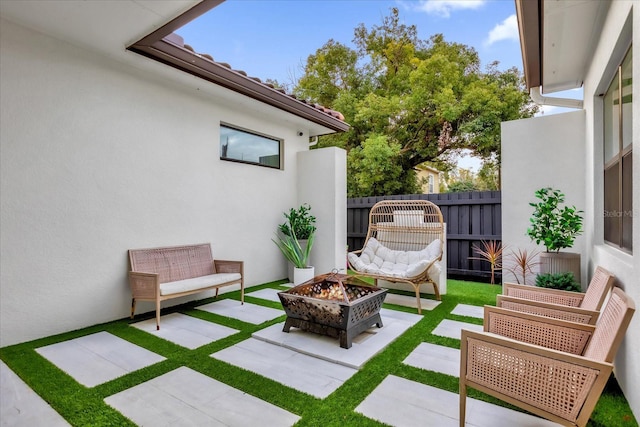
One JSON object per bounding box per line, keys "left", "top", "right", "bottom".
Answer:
{"left": 501, "top": 110, "right": 590, "bottom": 284}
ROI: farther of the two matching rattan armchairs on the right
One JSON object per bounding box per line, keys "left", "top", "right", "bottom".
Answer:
{"left": 496, "top": 266, "right": 615, "bottom": 325}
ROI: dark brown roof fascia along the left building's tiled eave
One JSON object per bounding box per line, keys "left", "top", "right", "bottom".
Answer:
{"left": 127, "top": 0, "right": 349, "bottom": 132}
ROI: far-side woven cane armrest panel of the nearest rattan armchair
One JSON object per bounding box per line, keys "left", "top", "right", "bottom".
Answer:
{"left": 484, "top": 306, "right": 595, "bottom": 354}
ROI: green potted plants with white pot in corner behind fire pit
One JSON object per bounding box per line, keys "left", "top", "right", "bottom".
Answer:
{"left": 274, "top": 204, "right": 316, "bottom": 285}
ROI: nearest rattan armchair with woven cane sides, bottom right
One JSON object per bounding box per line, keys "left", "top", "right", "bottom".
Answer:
{"left": 460, "top": 288, "right": 635, "bottom": 427}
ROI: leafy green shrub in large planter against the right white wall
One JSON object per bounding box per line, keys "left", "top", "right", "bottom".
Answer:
{"left": 527, "top": 187, "right": 583, "bottom": 283}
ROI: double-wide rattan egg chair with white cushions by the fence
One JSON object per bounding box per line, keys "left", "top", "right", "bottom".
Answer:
{"left": 347, "top": 200, "right": 446, "bottom": 313}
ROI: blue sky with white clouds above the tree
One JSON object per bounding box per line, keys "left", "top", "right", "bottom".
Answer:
{"left": 177, "top": 0, "right": 522, "bottom": 84}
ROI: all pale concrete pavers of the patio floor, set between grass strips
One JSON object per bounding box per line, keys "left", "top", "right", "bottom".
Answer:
{"left": 0, "top": 289, "right": 556, "bottom": 427}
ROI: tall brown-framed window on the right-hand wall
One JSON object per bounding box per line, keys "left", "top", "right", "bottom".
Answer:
{"left": 604, "top": 48, "right": 633, "bottom": 252}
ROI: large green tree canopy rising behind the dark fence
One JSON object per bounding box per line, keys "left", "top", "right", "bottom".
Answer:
{"left": 294, "top": 8, "right": 537, "bottom": 197}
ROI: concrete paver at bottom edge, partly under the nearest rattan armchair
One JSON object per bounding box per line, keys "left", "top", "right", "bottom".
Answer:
{"left": 355, "top": 375, "right": 557, "bottom": 427}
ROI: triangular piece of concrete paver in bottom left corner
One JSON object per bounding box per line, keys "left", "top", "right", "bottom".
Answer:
{"left": 0, "top": 361, "right": 70, "bottom": 427}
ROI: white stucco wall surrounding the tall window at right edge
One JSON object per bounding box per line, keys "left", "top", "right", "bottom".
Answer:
{"left": 584, "top": 0, "right": 640, "bottom": 419}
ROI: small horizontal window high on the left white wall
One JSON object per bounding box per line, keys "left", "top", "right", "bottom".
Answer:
{"left": 220, "top": 125, "right": 282, "bottom": 169}
